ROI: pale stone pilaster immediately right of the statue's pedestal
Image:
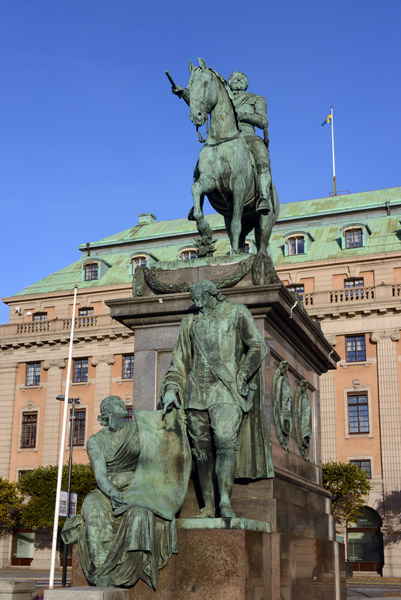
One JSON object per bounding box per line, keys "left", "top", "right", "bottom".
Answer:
{"left": 319, "top": 335, "right": 337, "bottom": 463}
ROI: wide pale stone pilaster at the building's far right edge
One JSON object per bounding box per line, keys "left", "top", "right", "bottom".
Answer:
{"left": 371, "top": 330, "right": 401, "bottom": 516}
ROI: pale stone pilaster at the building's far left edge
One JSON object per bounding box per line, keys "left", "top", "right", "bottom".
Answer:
{"left": 0, "top": 357, "right": 17, "bottom": 479}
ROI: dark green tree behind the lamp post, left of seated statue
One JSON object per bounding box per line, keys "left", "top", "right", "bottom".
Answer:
{"left": 18, "top": 465, "right": 96, "bottom": 529}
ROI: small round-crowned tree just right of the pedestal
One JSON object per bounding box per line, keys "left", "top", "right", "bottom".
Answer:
{"left": 322, "top": 461, "right": 372, "bottom": 557}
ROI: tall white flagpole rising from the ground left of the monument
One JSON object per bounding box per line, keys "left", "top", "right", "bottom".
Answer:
{"left": 49, "top": 285, "right": 78, "bottom": 590}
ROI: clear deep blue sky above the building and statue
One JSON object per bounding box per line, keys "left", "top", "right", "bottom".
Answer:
{"left": 0, "top": 0, "right": 401, "bottom": 323}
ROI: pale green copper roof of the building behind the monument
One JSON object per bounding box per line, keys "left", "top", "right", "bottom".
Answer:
{"left": 7, "top": 187, "right": 401, "bottom": 296}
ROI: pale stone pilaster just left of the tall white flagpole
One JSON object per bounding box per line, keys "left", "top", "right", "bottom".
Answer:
{"left": 42, "top": 358, "right": 65, "bottom": 467}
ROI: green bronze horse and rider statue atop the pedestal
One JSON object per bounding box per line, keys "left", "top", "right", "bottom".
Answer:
{"left": 168, "top": 58, "right": 279, "bottom": 255}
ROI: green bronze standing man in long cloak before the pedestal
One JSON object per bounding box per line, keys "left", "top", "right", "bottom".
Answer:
{"left": 161, "top": 280, "right": 274, "bottom": 518}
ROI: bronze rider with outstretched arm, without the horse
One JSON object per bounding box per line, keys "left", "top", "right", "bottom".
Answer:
{"left": 172, "top": 71, "right": 273, "bottom": 215}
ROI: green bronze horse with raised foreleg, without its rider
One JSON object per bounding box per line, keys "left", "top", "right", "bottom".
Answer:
{"left": 172, "top": 58, "right": 279, "bottom": 254}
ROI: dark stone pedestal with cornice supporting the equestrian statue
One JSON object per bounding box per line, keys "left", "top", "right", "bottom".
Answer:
{"left": 103, "top": 257, "right": 345, "bottom": 600}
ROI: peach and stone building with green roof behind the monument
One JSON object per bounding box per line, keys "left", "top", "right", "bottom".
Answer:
{"left": 0, "top": 187, "right": 401, "bottom": 576}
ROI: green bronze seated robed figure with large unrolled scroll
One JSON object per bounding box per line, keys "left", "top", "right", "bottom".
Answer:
{"left": 61, "top": 396, "right": 191, "bottom": 589}
